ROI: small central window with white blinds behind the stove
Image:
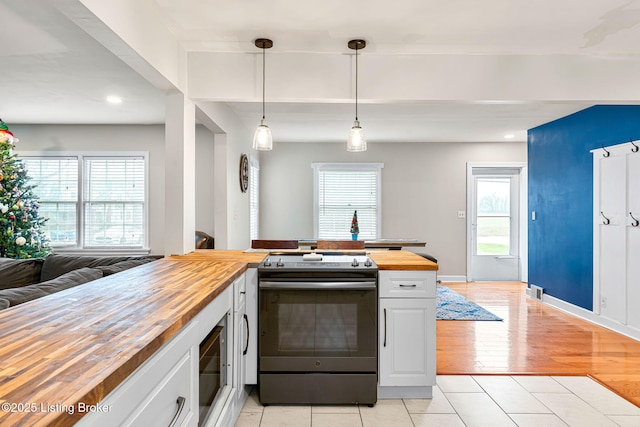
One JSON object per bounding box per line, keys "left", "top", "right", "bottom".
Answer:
{"left": 312, "top": 163, "right": 384, "bottom": 240}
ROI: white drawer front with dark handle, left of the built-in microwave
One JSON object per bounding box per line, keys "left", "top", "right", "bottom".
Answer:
{"left": 124, "top": 353, "right": 194, "bottom": 426}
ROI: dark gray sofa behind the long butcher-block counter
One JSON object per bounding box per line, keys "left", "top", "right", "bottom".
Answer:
{"left": 0, "top": 254, "right": 162, "bottom": 310}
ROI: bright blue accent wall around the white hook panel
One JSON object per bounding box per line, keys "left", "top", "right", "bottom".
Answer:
{"left": 527, "top": 105, "right": 640, "bottom": 310}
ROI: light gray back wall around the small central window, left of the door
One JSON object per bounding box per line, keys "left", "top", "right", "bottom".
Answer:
{"left": 260, "top": 142, "right": 527, "bottom": 276}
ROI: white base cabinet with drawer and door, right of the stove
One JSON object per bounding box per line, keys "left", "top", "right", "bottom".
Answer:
{"left": 378, "top": 270, "right": 436, "bottom": 399}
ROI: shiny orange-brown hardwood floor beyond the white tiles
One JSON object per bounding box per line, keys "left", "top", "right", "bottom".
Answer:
{"left": 436, "top": 282, "right": 640, "bottom": 406}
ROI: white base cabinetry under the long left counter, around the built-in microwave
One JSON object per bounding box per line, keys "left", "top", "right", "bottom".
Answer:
{"left": 76, "top": 280, "right": 247, "bottom": 427}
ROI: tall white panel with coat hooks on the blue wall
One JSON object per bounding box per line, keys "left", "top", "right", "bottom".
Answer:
{"left": 592, "top": 141, "right": 640, "bottom": 336}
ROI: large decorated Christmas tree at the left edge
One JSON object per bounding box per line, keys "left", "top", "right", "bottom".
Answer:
{"left": 0, "top": 119, "right": 50, "bottom": 258}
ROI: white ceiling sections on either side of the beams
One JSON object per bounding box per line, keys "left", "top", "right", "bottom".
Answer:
{"left": 0, "top": 0, "right": 640, "bottom": 142}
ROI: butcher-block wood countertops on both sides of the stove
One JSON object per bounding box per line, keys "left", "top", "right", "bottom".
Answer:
{"left": 0, "top": 250, "right": 437, "bottom": 426}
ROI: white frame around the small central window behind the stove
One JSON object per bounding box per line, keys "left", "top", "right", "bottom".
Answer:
{"left": 311, "top": 162, "right": 384, "bottom": 239}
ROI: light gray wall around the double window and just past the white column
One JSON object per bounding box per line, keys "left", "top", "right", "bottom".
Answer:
{"left": 11, "top": 125, "right": 214, "bottom": 254}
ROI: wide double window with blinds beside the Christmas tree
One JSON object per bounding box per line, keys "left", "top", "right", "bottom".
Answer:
{"left": 20, "top": 153, "right": 147, "bottom": 249}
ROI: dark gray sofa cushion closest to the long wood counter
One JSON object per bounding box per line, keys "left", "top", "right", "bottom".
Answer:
{"left": 0, "top": 268, "right": 102, "bottom": 307}
